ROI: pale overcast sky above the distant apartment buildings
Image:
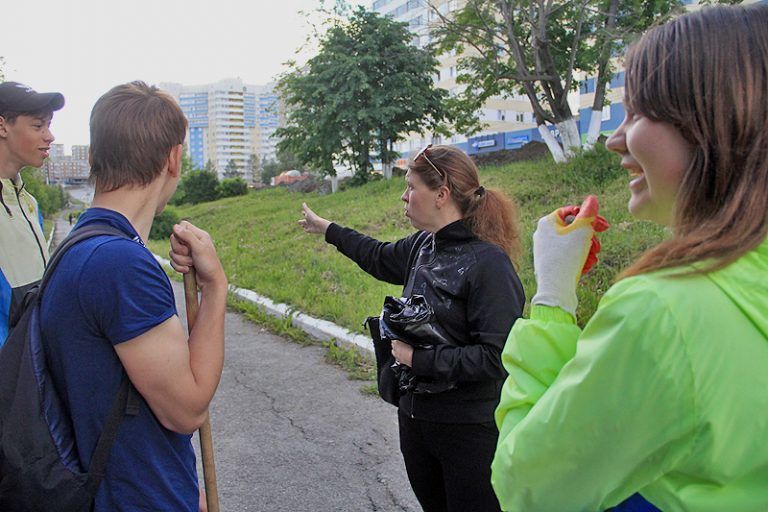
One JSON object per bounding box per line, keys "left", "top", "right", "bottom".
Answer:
{"left": 0, "top": 0, "right": 371, "bottom": 150}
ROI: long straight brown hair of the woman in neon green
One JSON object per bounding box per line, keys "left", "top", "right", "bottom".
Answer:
{"left": 621, "top": 5, "right": 768, "bottom": 277}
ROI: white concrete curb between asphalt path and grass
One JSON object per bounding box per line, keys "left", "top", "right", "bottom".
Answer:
{"left": 153, "top": 254, "right": 373, "bottom": 357}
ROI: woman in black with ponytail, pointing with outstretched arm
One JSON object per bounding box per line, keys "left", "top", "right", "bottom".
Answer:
{"left": 299, "top": 145, "right": 525, "bottom": 512}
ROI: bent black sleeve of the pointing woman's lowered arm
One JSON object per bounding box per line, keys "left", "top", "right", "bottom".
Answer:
{"left": 412, "top": 253, "right": 525, "bottom": 382}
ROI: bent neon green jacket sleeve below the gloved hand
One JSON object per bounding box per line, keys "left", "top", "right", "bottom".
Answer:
{"left": 491, "top": 277, "right": 696, "bottom": 511}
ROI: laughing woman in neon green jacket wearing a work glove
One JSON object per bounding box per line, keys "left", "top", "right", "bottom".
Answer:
{"left": 492, "top": 4, "right": 768, "bottom": 512}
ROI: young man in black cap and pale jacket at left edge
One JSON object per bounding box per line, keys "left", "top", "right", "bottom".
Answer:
{"left": 0, "top": 82, "right": 64, "bottom": 346}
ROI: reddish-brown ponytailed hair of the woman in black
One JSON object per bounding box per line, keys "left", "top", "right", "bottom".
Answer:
{"left": 408, "top": 146, "right": 522, "bottom": 266}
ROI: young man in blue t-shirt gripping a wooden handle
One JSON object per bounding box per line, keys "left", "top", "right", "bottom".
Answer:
{"left": 40, "top": 82, "right": 227, "bottom": 512}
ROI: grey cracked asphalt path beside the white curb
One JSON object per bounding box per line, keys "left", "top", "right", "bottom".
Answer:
{"left": 174, "top": 282, "right": 420, "bottom": 512}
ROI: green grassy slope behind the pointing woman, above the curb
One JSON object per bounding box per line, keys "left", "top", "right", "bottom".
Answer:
{"left": 150, "top": 148, "right": 663, "bottom": 331}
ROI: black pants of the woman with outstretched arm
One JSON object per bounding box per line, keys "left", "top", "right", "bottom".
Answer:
{"left": 398, "top": 412, "right": 501, "bottom": 512}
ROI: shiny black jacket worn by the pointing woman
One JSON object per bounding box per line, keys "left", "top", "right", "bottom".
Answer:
{"left": 325, "top": 220, "right": 525, "bottom": 423}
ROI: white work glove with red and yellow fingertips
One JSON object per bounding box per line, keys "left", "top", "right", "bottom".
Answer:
{"left": 531, "top": 196, "right": 608, "bottom": 316}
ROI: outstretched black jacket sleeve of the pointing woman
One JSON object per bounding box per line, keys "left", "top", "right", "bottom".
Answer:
{"left": 325, "top": 223, "right": 427, "bottom": 285}
